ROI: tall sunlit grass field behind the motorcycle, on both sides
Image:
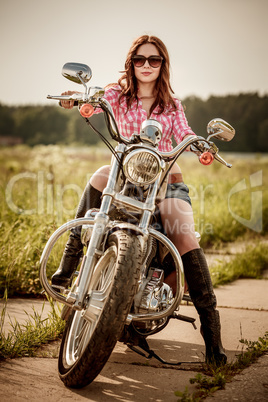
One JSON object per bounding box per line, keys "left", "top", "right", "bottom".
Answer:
{"left": 0, "top": 146, "right": 268, "bottom": 297}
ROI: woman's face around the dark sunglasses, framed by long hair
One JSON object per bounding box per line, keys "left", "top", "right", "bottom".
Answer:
{"left": 134, "top": 43, "right": 161, "bottom": 84}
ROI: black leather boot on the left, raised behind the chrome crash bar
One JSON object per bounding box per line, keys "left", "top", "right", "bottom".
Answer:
{"left": 51, "top": 182, "right": 102, "bottom": 287}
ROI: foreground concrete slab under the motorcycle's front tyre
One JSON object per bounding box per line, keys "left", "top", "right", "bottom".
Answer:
{"left": 0, "top": 358, "right": 199, "bottom": 402}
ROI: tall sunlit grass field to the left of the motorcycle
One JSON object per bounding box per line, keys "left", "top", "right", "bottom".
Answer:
{"left": 0, "top": 146, "right": 110, "bottom": 297}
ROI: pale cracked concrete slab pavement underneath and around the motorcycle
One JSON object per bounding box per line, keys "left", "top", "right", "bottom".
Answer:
{"left": 0, "top": 280, "right": 268, "bottom": 402}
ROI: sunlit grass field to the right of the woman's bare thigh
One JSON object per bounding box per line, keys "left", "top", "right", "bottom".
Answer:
{"left": 181, "top": 155, "right": 268, "bottom": 248}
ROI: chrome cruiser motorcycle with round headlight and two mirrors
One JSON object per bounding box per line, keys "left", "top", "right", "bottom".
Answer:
{"left": 40, "top": 63, "right": 235, "bottom": 388}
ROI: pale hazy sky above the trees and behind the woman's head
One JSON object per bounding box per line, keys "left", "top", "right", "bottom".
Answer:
{"left": 0, "top": 0, "right": 268, "bottom": 105}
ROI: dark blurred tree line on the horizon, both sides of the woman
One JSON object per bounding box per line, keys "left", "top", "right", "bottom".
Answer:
{"left": 0, "top": 93, "right": 268, "bottom": 152}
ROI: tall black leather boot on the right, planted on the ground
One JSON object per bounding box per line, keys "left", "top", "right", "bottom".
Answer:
{"left": 181, "top": 248, "right": 227, "bottom": 366}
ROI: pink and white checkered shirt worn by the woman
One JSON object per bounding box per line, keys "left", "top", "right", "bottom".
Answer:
{"left": 95, "top": 85, "right": 195, "bottom": 152}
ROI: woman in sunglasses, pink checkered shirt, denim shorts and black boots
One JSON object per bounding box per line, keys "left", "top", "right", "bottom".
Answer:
{"left": 52, "top": 35, "right": 227, "bottom": 365}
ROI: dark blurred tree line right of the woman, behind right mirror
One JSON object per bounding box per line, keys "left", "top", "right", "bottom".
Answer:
{"left": 183, "top": 93, "right": 268, "bottom": 152}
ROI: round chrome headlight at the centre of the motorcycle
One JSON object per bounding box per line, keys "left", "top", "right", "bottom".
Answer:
{"left": 123, "top": 150, "right": 161, "bottom": 185}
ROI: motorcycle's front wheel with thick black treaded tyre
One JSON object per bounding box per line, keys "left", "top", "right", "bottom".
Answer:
{"left": 58, "top": 230, "right": 142, "bottom": 388}
